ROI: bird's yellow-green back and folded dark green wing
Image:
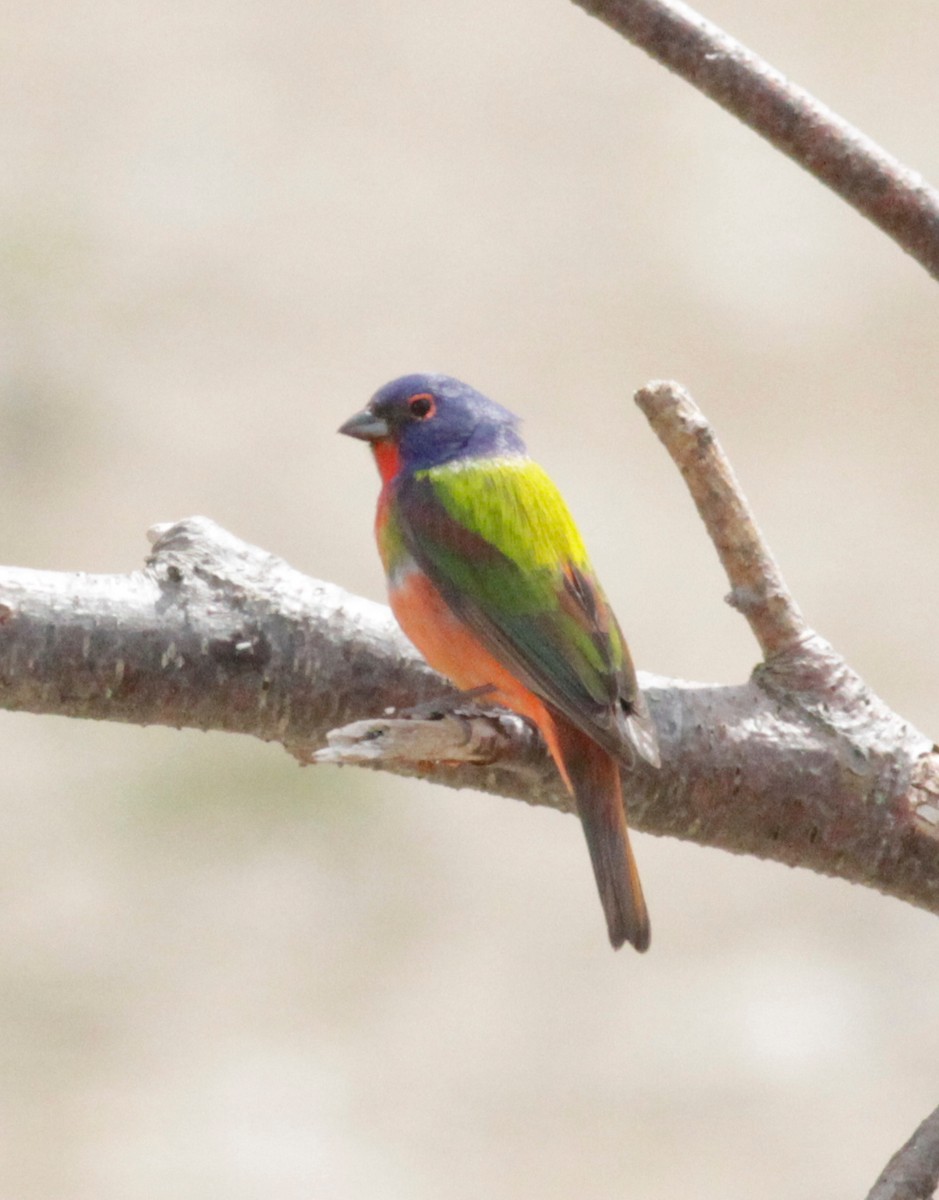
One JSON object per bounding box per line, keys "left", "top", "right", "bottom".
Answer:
{"left": 395, "top": 458, "right": 658, "bottom": 766}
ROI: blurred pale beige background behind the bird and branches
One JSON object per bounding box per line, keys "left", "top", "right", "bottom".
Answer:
{"left": 0, "top": 0, "right": 939, "bottom": 1200}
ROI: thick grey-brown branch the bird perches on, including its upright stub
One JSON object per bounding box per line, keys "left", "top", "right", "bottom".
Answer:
{"left": 0, "top": 384, "right": 939, "bottom": 912}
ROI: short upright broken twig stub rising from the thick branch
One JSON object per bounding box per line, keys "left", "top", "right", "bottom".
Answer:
{"left": 635, "top": 380, "right": 808, "bottom": 659}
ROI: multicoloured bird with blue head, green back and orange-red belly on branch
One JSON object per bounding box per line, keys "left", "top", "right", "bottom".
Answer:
{"left": 339, "top": 374, "right": 659, "bottom": 950}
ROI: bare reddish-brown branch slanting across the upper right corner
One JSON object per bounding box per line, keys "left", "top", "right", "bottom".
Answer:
{"left": 574, "top": 0, "right": 939, "bottom": 278}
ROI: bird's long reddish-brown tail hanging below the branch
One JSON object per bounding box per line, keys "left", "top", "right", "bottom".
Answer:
{"left": 557, "top": 720, "right": 650, "bottom": 950}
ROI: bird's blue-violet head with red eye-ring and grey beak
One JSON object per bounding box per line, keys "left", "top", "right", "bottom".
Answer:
{"left": 340, "top": 374, "right": 525, "bottom": 479}
